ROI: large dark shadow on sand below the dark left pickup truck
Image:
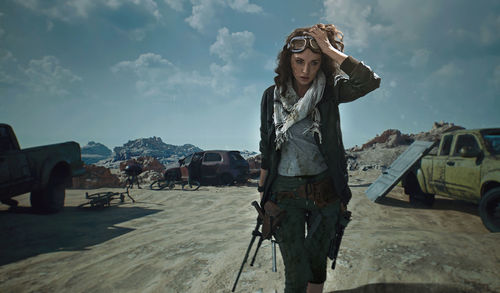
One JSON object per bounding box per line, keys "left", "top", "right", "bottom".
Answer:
{"left": 0, "top": 206, "right": 161, "bottom": 266}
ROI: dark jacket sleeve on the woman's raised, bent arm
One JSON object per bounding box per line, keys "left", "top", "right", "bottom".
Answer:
{"left": 335, "top": 56, "right": 380, "bottom": 103}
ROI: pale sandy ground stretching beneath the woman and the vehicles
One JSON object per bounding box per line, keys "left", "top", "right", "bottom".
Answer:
{"left": 0, "top": 170, "right": 500, "bottom": 293}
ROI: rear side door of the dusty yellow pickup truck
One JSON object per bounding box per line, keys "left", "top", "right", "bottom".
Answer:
{"left": 429, "top": 134, "right": 453, "bottom": 194}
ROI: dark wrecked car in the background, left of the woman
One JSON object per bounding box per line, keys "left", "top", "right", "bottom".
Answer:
{"left": 165, "top": 150, "right": 249, "bottom": 185}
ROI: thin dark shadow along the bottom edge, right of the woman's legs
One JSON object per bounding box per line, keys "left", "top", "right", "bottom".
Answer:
{"left": 329, "top": 283, "right": 494, "bottom": 293}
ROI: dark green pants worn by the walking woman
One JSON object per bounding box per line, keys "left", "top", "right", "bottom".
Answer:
{"left": 274, "top": 193, "right": 340, "bottom": 293}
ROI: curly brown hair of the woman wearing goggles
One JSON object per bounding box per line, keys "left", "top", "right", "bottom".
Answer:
{"left": 274, "top": 23, "right": 344, "bottom": 94}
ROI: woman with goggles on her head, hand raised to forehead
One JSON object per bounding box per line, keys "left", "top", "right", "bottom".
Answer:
{"left": 259, "top": 24, "right": 380, "bottom": 292}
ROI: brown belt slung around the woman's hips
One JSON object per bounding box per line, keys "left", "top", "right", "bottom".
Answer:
{"left": 276, "top": 176, "right": 340, "bottom": 208}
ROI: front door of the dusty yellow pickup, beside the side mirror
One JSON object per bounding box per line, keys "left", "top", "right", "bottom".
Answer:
{"left": 445, "top": 134, "right": 481, "bottom": 199}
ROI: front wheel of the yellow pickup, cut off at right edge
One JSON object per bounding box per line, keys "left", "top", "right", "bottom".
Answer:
{"left": 479, "top": 187, "right": 500, "bottom": 232}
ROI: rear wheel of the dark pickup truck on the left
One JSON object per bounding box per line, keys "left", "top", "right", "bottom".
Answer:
{"left": 30, "top": 176, "right": 66, "bottom": 214}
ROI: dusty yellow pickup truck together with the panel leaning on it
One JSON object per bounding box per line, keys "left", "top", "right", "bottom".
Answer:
{"left": 366, "top": 128, "right": 500, "bottom": 232}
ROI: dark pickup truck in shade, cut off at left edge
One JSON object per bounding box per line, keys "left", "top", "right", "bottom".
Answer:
{"left": 0, "top": 124, "right": 85, "bottom": 213}
